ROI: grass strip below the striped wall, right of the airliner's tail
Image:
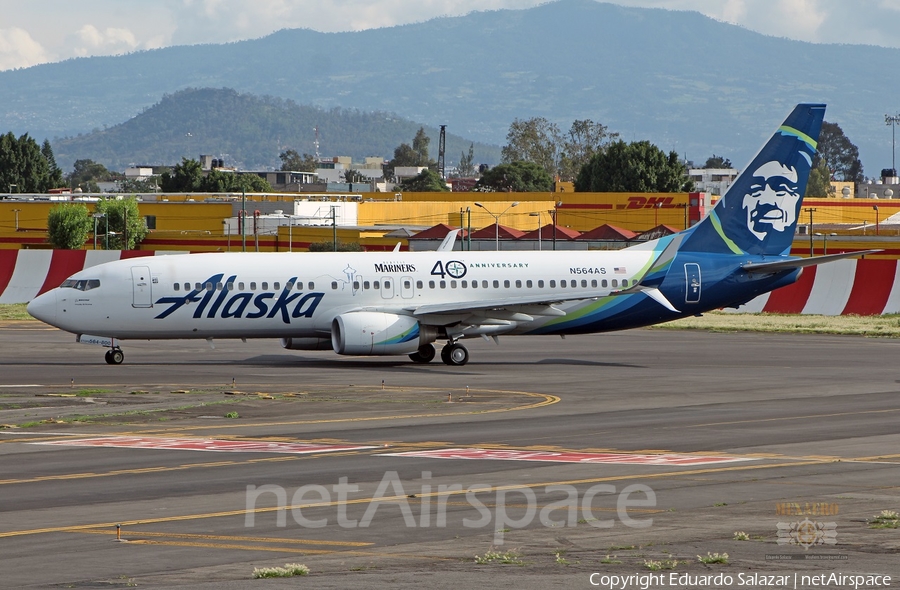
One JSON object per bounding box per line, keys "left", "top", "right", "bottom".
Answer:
{"left": 653, "top": 311, "right": 900, "bottom": 338}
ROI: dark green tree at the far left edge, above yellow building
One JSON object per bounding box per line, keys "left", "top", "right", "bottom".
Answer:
{"left": 0, "top": 132, "right": 57, "bottom": 193}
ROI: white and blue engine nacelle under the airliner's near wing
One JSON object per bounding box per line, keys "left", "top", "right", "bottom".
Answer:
{"left": 331, "top": 311, "right": 438, "bottom": 355}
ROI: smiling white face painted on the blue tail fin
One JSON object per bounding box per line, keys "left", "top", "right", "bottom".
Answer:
{"left": 743, "top": 161, "right": 801, "bottom": 241}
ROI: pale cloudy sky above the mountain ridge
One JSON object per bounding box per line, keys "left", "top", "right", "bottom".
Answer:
{"left": 0, "top": 0, "right": 900, "bottom": 70}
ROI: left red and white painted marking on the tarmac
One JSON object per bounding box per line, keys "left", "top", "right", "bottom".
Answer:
{"left": 37, "top": 436, "right": 375, "bottom": 455}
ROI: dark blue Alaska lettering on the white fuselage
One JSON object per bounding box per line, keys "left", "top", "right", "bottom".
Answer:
{"left": 154, "top": 274, "right": 325, "bottom": 324}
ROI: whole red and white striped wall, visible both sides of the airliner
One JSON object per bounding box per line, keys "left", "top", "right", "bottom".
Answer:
{"left": 0, "top": 250, "right": 900, "bottom": 315}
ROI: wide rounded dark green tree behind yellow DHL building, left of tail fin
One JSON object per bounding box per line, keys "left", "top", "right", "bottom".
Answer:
{"left": 575, "top": 140, "right": 694, "bottom": 193}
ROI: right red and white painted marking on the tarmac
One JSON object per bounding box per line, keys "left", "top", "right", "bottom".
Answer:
{"left": 378, "top": 448, "right": 756, "bottom": 465}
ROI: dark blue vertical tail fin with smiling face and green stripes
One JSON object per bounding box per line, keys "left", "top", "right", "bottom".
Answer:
{"left": 679, "top": 104, "right": 825, "bottom": 256}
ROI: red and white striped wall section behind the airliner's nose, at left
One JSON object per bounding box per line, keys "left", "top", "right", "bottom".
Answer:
{"left": 0, "top": 250, "right": 187, "bottom": 303}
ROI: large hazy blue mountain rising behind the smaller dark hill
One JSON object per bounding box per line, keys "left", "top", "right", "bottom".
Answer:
{"left": 0, "top": 0, "right": 900, "bottom": 176}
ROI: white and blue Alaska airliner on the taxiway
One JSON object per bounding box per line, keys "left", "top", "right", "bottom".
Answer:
{"left": 28, "top": 104, "right": 862, "bottom": 365}
